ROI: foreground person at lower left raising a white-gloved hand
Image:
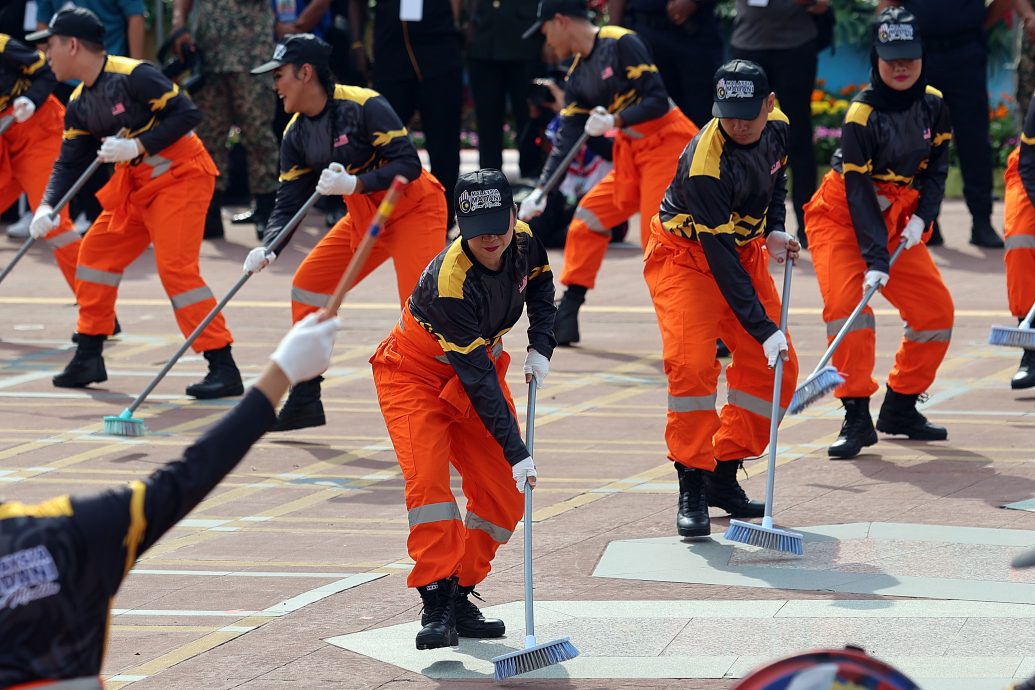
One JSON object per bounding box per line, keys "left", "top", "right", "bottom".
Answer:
{"left": 0, "top": 312, "right": 339, "bottom": 690}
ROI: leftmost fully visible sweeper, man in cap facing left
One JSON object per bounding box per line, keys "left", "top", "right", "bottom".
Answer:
{"left": 28, "top": 7, "right": 244, "bottom": 398}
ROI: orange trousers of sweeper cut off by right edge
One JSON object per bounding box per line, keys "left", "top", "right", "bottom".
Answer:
{"left": 1003, "top": 149, "right": 1035, "bottom": 319}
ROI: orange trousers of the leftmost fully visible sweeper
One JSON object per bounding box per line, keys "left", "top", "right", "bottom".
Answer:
{"left": 76, "top": 134, "right": 233, "bottom": 352}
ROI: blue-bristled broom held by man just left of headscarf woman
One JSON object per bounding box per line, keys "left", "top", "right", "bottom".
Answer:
{"left": 726, "top": 261, "right": 805, "bottom": 556}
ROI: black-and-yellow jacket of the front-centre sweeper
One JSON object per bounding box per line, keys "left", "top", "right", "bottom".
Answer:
{"left": 408, "top": 220, "right": 557, "bottom": 464}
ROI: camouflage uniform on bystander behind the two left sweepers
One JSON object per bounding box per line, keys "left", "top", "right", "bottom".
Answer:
{"left": 191, "top": 0, "right": 279, "bottom": 194}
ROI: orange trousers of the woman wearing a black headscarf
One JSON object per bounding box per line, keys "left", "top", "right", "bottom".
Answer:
{"left": 805, "top": 171, "right": 953, "bottom": 397}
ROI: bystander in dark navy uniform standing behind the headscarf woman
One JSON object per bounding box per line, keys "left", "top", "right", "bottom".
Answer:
{"left": 878, "top": 0, "right": 1003, "bottom": 249}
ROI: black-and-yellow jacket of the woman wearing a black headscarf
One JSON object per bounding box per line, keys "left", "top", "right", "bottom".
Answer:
{"left": 830, "top": 86, "right": 952, "bottom": 273}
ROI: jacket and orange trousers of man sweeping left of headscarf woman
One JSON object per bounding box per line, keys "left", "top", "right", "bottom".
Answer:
{"left": 644, "top": 111, "right": 798, "bottom": 472}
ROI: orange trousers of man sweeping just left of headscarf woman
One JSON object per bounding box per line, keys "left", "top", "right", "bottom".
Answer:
{"left": 644, "top": 214, "right": 798, "bottom": 470}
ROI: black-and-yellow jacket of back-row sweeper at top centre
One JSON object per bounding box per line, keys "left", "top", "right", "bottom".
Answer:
{"left": 539, "top": 26, "right": 670, "bottom": 189}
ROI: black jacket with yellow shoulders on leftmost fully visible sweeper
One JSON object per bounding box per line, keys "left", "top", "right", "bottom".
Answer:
{"left": 43, "top": 55, "right": 201, "bottom": 206}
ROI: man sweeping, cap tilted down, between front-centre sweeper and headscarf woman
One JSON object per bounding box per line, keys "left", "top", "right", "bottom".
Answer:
{"left": 644, "top": 60, "right": 801, "bottom": 537}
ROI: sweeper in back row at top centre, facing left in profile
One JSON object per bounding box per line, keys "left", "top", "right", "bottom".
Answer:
{"left": 518, "top": 0, "right": 698, "bottom": 346}
